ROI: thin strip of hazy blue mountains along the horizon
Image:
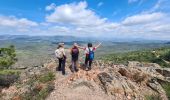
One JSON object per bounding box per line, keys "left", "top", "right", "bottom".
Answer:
{"left": 0, "top": 35, "right": 169, "bottom": 44}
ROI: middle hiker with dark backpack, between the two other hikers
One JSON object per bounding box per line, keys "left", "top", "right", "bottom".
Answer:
{"left": 70, "top": 43, "right": 79, "bottom": 72}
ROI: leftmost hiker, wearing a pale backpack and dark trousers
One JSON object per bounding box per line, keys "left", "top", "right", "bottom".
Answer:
{"left": 55, "top": 43, "right": 66, "bottom": 75}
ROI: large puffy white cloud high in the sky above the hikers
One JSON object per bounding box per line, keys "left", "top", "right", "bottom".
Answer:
{"left": 46, "top": 2, "right": 106, "bottom": 26}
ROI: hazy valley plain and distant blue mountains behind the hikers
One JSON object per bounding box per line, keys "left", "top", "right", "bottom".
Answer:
{"left": 0, "top": 35, "right": 170, "bottom": 67}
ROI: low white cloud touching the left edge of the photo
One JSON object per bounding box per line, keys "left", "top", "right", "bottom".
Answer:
{"left": 0, "top": 16, "right": 39, "bottom": 34}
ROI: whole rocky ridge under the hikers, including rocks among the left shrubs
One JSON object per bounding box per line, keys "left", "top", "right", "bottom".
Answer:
{"left": 1, "top": 59, "right": 170, "bottom": 100}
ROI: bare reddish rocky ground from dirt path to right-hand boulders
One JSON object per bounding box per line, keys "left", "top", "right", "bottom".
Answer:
{"left": 47, "top": 61, "right": 168, "bottom": 100}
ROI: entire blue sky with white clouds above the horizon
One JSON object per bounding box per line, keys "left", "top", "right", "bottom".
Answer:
{"left": 0, "top": 0, "right": 170, "bottom": 40}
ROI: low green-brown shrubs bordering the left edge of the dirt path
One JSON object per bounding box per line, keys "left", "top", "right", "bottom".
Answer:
{"left": 20, "top": 72, "right": 55, "bottom": 100}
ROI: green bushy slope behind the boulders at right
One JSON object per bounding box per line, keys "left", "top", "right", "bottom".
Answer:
{"left": 101, "top": 47, "right": 170, "bottom": 67}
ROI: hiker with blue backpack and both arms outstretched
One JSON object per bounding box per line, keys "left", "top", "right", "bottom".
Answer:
{"left": 78, "top": 43, "right": 101, "bottom": 71}
